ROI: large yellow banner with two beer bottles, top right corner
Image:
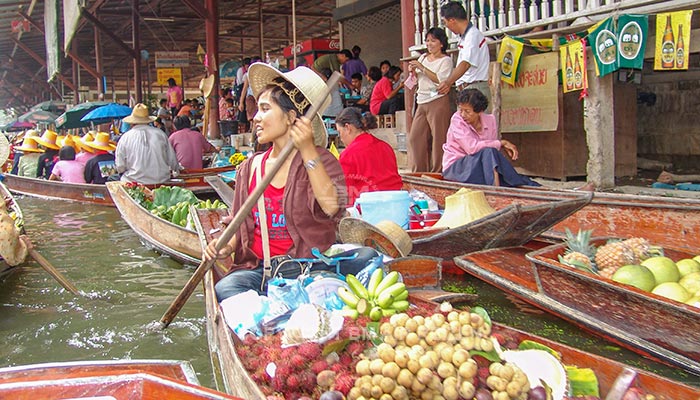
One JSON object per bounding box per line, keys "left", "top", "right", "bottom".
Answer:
{"left": 654, "top": 10, "right": 693, "bottom": 71}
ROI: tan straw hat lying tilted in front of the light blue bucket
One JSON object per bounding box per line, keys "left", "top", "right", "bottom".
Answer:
{"left": 338, "top": 217, "right": 413, "bottom": 258}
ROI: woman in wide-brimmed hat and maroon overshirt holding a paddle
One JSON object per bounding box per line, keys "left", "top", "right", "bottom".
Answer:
{"left": 202, "top": 63, "right": 376, "bottom": 301}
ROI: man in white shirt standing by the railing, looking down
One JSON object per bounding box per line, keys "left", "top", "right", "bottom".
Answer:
{"left": 437, "top": 1, "right": 491, "bottom": 109}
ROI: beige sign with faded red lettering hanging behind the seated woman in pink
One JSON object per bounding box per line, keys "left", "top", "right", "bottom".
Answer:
{"left": 499, "top": 52, "right": 559, "bottom": 132}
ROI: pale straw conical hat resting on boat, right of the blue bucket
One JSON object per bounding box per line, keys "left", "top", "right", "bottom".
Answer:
{"left": 433, "top": 188, "right": 496, "bottom": 228}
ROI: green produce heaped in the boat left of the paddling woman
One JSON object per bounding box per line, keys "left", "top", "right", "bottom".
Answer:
{"left": 125, "top": 183, "right": 227, "bottom": 227}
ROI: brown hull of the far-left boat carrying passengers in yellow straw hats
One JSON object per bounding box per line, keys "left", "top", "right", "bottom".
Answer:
{"left": 4, "top": 174, "right": 114, "bottom": 207}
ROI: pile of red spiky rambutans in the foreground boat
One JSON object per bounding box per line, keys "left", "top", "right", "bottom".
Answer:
{"left": 236, "top": 317, "right": 372, "bottom": 399}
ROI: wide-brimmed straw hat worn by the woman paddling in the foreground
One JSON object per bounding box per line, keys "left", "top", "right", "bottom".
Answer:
{"left": 248, "top": 63, "right": 331, "bottom": 147}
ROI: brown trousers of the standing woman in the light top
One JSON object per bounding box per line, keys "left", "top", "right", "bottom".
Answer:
{"left": 408, "top": 96, "right": 452, "bottom": 172}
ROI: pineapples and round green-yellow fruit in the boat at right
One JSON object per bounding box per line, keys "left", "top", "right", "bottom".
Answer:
{"left": 559, "top": 231, "right": 700, "bottom": 307}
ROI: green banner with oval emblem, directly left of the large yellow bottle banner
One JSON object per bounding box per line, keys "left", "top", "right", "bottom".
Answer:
{"left": 617, "top": 14, "right": 652, "bottom": 69}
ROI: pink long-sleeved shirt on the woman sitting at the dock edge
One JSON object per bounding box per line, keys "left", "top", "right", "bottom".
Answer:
{"left": 442, "top": 111, "right": 501, "bottom": 171}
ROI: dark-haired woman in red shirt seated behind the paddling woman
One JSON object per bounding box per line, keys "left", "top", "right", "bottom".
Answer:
{"left": 335, "top": 107, "right": 403, "bottom": 205}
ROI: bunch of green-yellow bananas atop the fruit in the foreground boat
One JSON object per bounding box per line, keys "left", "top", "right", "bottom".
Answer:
{"left": 338, "top": 268, "right": 408, "bottom": 321}
